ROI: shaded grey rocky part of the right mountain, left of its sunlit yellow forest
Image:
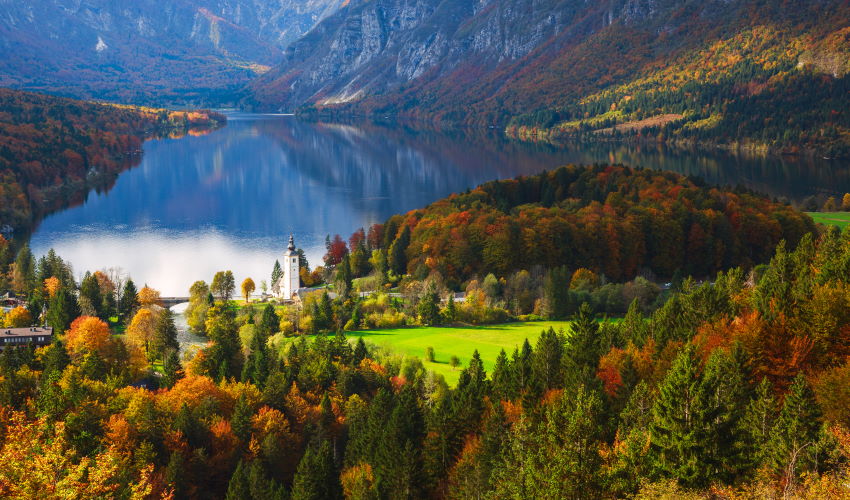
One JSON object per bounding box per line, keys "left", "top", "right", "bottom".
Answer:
{"left": 246, "top": 0, "right": 840, "bottom": 123}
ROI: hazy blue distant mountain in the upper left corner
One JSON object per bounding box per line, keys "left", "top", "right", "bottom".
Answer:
{"left": 0, "top": 0, "right": 344, "bottom": 103}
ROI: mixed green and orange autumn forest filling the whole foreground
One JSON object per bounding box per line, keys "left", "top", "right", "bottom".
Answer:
{"left": 0, "top": 210, "right": 850, "bottom": 500}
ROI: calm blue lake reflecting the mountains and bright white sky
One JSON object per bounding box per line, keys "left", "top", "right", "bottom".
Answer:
{"left": 26, "top": 114, "right": 850, "bottom": 296}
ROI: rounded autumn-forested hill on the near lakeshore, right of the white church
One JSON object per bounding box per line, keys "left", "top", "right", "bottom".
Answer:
{"left": 372, "top": 166, "right": 814, "bottom": 283}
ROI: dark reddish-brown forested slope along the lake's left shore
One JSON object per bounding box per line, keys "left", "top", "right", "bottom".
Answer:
{"left": 0, "top": 89, "right": 225, "bottom": 233}
